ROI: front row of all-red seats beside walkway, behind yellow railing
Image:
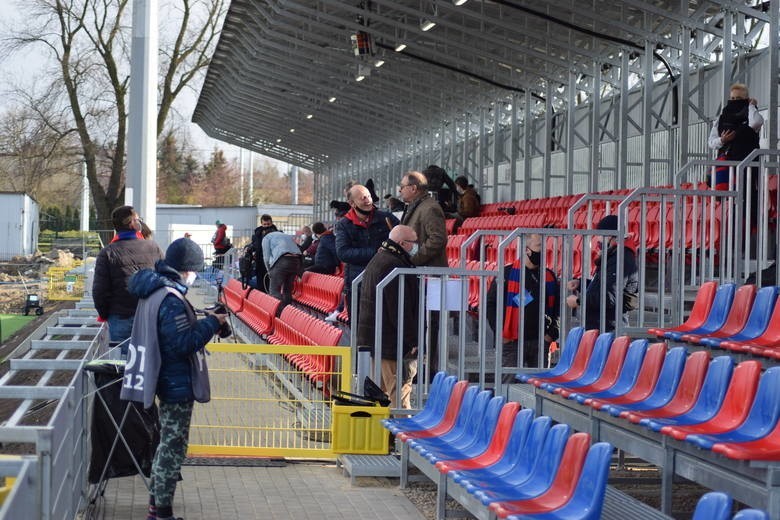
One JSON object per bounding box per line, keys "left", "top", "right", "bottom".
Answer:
{"left": 222, "top": 279, "right": 342, "bottom": 383}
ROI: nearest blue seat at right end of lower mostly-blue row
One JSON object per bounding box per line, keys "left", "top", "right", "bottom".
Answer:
{"left": 507, "top": 442, "right": 612, "bottom": 520}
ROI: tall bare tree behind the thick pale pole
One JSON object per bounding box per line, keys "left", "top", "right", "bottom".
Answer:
{"left": 4, "top": 0, "right": 226, "bottom": 230}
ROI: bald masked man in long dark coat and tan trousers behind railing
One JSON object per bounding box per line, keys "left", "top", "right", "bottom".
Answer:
{"left": 357, "top": 225, "right": 419, "bottom": 409}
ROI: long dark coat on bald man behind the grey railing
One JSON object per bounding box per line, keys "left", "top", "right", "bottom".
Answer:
{"left": 357, "top": 239, "right": 419, "bottom": 360}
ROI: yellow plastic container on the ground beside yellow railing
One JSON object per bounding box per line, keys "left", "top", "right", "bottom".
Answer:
{"left": 331, "top": 404, "right": 390, "bottom": 455}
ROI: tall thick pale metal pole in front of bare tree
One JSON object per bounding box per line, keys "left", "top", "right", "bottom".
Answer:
{"left": 127, "top": 0, "right": 159, "bottom": 229}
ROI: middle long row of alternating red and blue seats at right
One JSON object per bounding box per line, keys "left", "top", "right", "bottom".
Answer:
{"left": 517, "top": 328, "right": 780, "bottom": 461}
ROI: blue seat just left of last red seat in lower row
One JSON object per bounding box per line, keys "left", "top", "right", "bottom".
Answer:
{"left": 471, "top": 424, "right": 571, "bottom": 505}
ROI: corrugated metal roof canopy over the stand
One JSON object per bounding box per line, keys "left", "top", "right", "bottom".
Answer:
{"left": 192, "top": 0, "right": 770, "bottom": 169}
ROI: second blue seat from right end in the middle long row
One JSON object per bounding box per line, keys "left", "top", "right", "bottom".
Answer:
{"left": 639, "top": 356, "right": 734, "bottom": 431}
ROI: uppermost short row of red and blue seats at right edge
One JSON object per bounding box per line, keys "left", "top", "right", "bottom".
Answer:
{"left": 648, "top": 281, "right": 780, "bottom": 359}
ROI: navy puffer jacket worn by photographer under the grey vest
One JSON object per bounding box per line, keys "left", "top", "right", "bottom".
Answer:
{"left": 128, "top": 260, "right": 219, "bottom": 403}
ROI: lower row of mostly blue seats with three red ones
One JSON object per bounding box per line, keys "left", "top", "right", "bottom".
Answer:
{"left": 384, "top": 373, "right": 612, "bottom": 519}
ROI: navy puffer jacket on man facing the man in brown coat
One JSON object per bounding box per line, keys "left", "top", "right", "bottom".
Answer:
{"left": 335, "top": 209, "right": 398, "bottom": 287}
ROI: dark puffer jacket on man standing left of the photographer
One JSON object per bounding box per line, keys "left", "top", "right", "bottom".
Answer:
{"left": 92, "top": 231, "right": 163, "bottom": 319}
